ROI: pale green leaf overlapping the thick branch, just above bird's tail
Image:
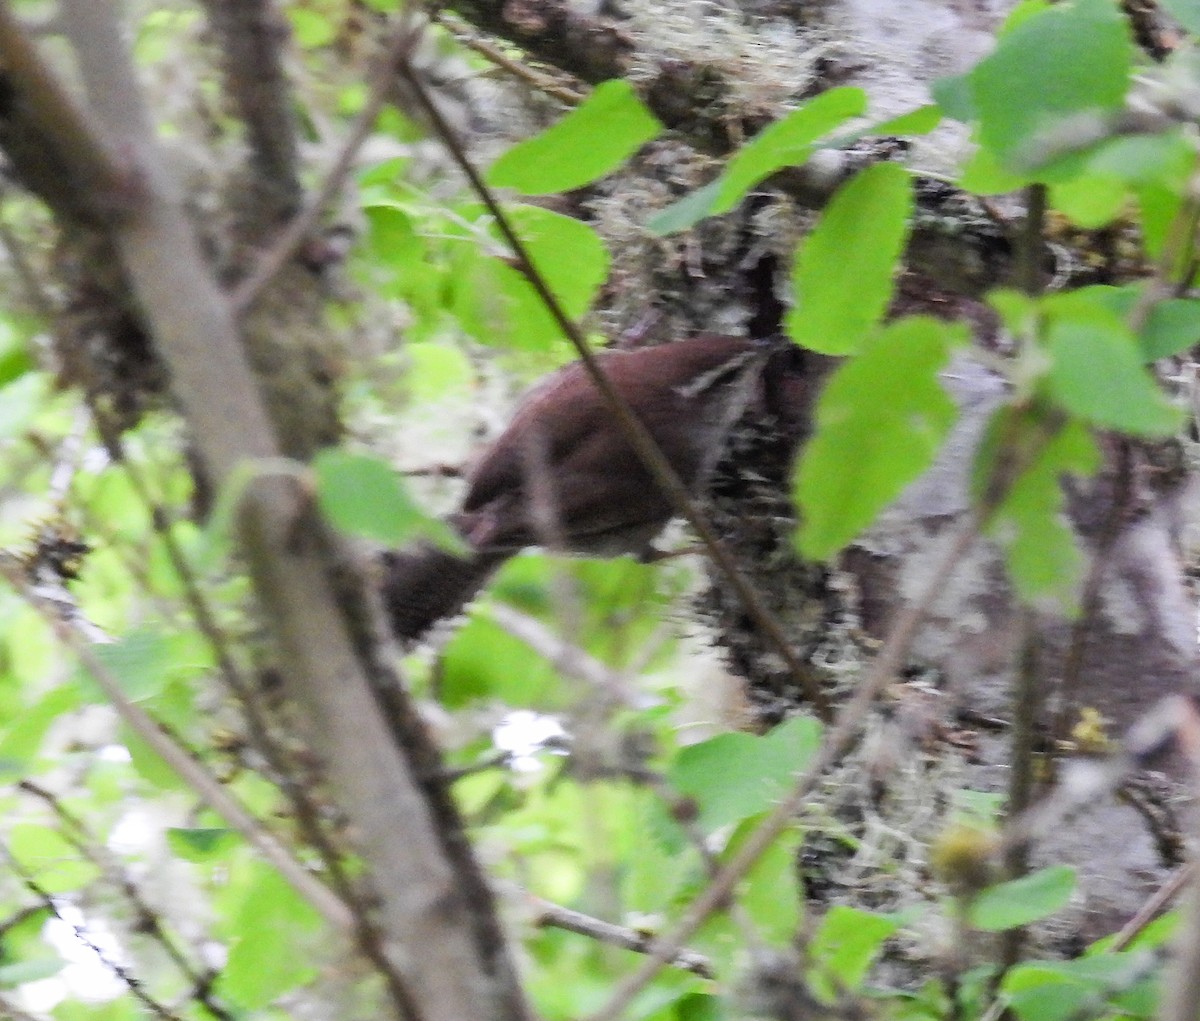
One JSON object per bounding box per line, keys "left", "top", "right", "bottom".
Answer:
{"left": 312, "top": 448, "right": 462, "bottom": 549}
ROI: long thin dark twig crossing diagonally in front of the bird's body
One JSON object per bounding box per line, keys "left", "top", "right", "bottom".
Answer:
{"left": 397, "top": 45, "right": 830, "bottom": 721}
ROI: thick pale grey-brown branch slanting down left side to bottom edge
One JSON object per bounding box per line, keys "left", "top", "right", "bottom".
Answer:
{"left": 51, "top": 0, "right": 528, "bottom": 1021}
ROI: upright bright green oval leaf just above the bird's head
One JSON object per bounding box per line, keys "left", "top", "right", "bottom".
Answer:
{"left": 787, "top": 163, "right": 913, "bottom": 354}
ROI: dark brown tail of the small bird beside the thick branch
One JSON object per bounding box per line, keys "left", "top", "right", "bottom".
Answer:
{"left": 380, "top": 542, "right": 508, "bottom": 641}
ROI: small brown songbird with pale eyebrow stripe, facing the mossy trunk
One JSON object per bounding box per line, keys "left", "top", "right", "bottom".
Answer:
{"left": 383, "top": 335, "right": 820, "bottom": 638}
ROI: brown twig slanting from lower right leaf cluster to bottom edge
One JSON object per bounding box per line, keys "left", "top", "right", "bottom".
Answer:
{"left": 588, "top": 510, "right": 986, "bottom": 1021}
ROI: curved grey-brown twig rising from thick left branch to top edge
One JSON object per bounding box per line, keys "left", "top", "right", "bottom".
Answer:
{"left": 229, "top": 18, "right": 418, "bottom": 318}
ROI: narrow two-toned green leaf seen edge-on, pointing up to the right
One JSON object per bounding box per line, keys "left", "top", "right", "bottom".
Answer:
{"left": 647, "top": 88, "right": 866, "bottom": 234}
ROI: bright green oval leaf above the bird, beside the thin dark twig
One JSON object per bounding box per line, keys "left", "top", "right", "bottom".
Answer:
{"left": 487, "top": 78, "right": 662, "bottom": 196}
